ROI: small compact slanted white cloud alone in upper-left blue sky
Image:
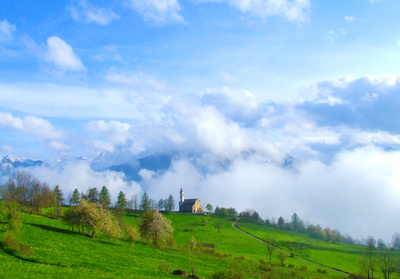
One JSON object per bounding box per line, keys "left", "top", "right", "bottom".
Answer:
{"left": 46, "top": 36, "right": 86, "bottom": 71}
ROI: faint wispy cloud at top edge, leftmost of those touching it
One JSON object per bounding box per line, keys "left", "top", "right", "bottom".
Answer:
{"left": 69, "top": 0, "right": 120, "bottom": 25}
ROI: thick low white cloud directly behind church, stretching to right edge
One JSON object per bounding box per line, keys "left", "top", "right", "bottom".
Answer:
{"left": 145, "top": 146, "right": 400, "bottom": 243}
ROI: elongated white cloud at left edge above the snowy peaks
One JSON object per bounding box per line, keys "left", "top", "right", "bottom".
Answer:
{"left": 0, "top": 112, "right": 67, "bottom": 150}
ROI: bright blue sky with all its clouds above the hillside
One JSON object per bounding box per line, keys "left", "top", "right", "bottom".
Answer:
{"left": 0, "top": 0, "right": 400, "bottom": 241}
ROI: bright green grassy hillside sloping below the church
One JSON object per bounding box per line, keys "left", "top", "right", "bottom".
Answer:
{"left": 0, "top": 213, "right": 380, "bottom": 278}
